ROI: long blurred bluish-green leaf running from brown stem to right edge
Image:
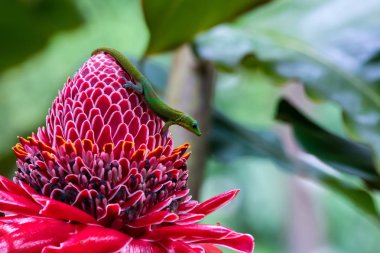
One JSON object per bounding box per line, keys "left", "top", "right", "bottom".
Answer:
{"left": 211, "top": 112, "right": 380, "bottom": 221}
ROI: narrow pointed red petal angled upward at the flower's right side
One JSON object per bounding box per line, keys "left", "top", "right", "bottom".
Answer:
{"left": 191, "top": 190, "right": 240, "bottom": 215}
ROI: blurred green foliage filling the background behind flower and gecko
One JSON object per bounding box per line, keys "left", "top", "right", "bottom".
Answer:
{"left": 0, "top": 0, "right": 380, "bottom": 253}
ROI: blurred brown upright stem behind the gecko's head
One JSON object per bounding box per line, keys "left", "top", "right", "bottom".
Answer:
{"left": 167, "top": 45, "right": 214, "bottom": 198}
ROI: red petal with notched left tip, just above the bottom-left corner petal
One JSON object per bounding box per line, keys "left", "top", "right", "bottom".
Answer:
{"left": 33, "top": 195, "right": 96, "bottom": 223}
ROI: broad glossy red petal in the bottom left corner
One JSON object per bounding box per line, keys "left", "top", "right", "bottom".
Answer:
{"left": 0, "top": 216, "right": 76, "bottom": 253}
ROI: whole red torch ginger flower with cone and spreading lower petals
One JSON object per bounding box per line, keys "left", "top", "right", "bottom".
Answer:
{"left": 0, "top": 54, "right": 254, "bottom": 253}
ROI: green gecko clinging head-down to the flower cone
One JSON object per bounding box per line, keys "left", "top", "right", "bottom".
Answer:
{"left": 92, "top": 48, "right": 201, "bottom": 136}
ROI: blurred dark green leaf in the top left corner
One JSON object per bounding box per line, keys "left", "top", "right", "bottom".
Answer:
{"left": 0, "top": 0, "right": 82, "bottom": 72}
